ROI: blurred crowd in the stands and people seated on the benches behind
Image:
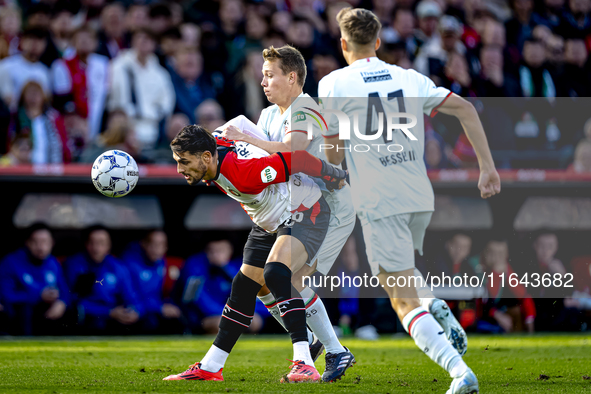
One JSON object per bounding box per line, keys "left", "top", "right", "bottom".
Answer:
{"left": 0, "top": 0, "right": 591, "bottom": 339}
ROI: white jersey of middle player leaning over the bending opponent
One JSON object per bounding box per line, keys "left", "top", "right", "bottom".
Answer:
{"left": 257, "top": 93, "right": 328, "bottom": 192}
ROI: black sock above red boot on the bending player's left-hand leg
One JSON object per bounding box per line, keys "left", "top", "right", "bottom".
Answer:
{"left": 213, "top": 271, "right": 262, "bottom": 353}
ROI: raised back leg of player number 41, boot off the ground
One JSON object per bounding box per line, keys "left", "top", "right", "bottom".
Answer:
{"left": 408, "top": 212, "right": 468, "bottom": 356}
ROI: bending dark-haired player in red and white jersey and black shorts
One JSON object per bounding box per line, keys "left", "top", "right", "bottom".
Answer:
{"left": 165, "top": 125, "right": 346, "bottom": 381}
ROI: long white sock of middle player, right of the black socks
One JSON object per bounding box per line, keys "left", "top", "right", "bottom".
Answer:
{"left": 301, "top": 287, "right": 346, "bottom": 354}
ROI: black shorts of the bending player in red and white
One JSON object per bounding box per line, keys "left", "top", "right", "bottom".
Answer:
{"left": 242, "top": 197, "right": 330, "bottom": 268}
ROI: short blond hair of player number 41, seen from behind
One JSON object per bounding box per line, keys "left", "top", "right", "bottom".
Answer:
{"left": 337, "top": 7, "right": 382, "bottom": 46}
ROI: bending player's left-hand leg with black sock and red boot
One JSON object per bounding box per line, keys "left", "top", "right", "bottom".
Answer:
{"left": 164, "top": 227, "right": 275, "bottom": 380}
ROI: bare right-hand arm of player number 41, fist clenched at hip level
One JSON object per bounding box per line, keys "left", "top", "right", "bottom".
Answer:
{"left": 438, "top": 93, "right": 501, "bottom": 198}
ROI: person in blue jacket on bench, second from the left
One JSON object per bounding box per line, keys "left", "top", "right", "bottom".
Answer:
{"left": 64, "top": 226, "right": 140, "bottom": 334}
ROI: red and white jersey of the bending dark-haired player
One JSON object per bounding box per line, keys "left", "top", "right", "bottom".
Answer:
{"left": 214, "top": 115, "right": 321, "bottom": 232}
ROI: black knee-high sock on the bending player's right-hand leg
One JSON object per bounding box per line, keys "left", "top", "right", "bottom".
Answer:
{"left": 264, "top": 262, "right": 308, "bottom": 343}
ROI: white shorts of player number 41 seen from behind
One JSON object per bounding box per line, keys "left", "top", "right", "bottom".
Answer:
{"left": 360, "top": 212, "right": 433, "bottom": 275}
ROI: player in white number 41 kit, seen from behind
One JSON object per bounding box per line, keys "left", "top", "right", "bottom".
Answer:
{"left": 318, "top": 8, "right": 501, "bottom": 394}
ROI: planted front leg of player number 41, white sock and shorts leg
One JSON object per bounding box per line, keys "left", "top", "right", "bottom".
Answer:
{"left": 362, "top": 214, "right": 478, "bottom": 393}
